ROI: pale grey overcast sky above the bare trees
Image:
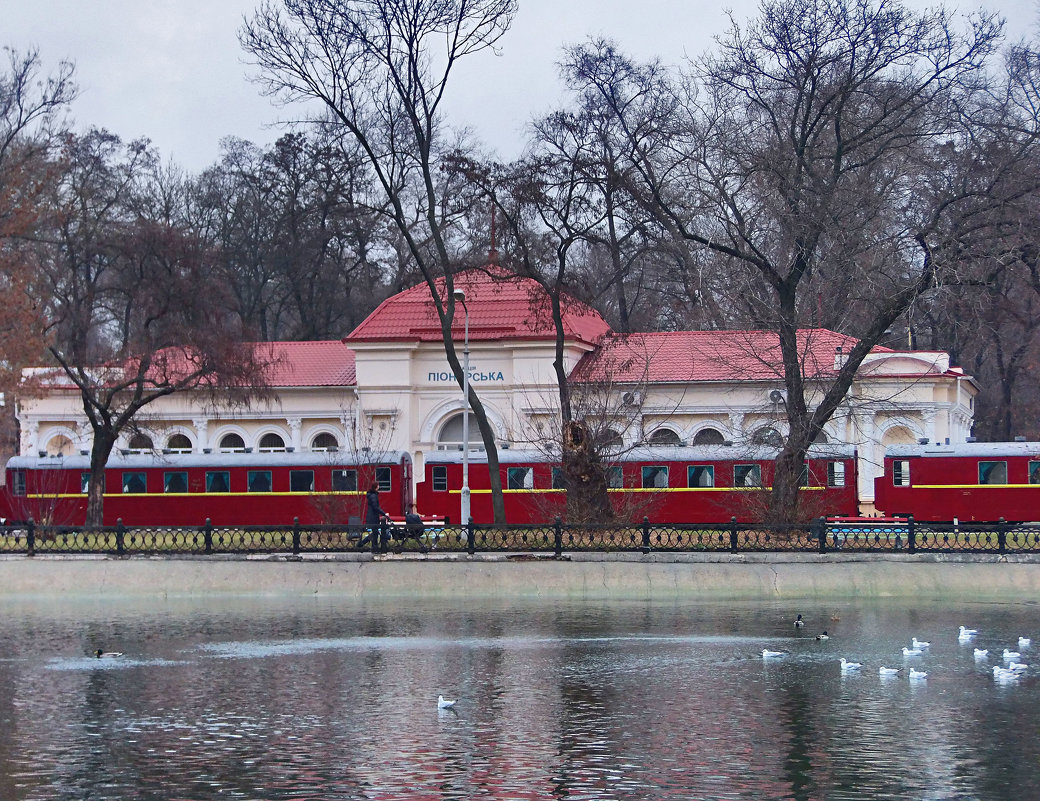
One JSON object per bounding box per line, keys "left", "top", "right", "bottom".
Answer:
{"left": 6, "top": 0, "right": 1040, "bottom": 172}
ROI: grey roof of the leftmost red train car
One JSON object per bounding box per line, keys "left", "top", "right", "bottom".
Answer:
{"left": 7, "top": 450, "right": 411, "bottom": 470}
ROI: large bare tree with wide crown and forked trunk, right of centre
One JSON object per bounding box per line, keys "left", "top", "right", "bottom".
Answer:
{"left": 575, "top": 0, "right": 1040, "bottom": 518}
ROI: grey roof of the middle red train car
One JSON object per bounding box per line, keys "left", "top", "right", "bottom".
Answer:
{"left": 425, "top": 443, "right": 856, "bottom": 464}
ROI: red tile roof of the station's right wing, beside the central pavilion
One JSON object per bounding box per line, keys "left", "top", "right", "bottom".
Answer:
{"left": 572, "top": 329, "right": 889, "bottom": 384}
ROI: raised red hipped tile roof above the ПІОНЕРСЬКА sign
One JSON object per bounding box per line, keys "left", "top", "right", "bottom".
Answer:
{"left": 343, "top": 267, "right": 610, "bottom": 344}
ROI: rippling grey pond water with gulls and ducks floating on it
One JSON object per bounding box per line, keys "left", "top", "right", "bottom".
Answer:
{"left": 0, "top": 597, "right": 1040, "bottom": 801}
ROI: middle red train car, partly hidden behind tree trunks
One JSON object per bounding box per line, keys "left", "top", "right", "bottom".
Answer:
{"left": 416, "top": 445, "right": 859, "bottom": 523}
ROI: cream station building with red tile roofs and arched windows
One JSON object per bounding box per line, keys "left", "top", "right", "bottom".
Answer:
{"left": 18, "top": 267, "right": 978, "bottom": 511}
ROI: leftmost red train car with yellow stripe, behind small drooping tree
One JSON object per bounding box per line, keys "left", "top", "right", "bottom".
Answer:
{"left": 2, "top": 451, "right": 412, "bottom": 526}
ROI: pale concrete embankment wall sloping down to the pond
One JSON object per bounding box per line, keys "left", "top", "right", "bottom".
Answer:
{"left": 0, "top": 553, "right": 1040, "bottom": 601}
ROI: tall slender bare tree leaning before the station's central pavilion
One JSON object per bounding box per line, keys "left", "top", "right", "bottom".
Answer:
{"left": 240, "top": 0, "right": 516, "bottom": 522}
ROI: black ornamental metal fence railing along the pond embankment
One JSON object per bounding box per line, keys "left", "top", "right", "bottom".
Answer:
{"left": 0, "top": 511, "right": 1040, "bottom": 555}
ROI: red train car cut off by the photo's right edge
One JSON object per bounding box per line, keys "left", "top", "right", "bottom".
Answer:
{"left": 874, "top": 442, "right": 1040, "bottom": 522}
